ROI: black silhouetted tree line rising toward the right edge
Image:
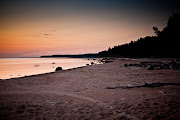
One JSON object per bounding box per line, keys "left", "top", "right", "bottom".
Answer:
{"left": 98, "top": 13, "right": 180, "bottom": 57}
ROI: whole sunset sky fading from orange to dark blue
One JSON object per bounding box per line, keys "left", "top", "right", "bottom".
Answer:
{"left": 0, "top": 0, "right": 180, "bottom": 57}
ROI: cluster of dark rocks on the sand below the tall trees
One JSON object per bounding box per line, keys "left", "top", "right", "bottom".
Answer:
{"left": 124, "top": 61, "right": 180, "bottom": 70}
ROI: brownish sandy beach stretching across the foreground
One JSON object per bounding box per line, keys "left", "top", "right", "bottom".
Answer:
{"left": 0, "top": 59, "right": 180, "bottom": 120}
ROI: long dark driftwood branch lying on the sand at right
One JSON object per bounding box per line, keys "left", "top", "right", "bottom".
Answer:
{"left": 107, "top": 83, "right": 180, "bottom": 89}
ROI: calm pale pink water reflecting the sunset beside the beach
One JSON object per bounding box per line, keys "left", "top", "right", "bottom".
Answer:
{"left": 0, "top": 58, "right": 95, "bottom": 79}
